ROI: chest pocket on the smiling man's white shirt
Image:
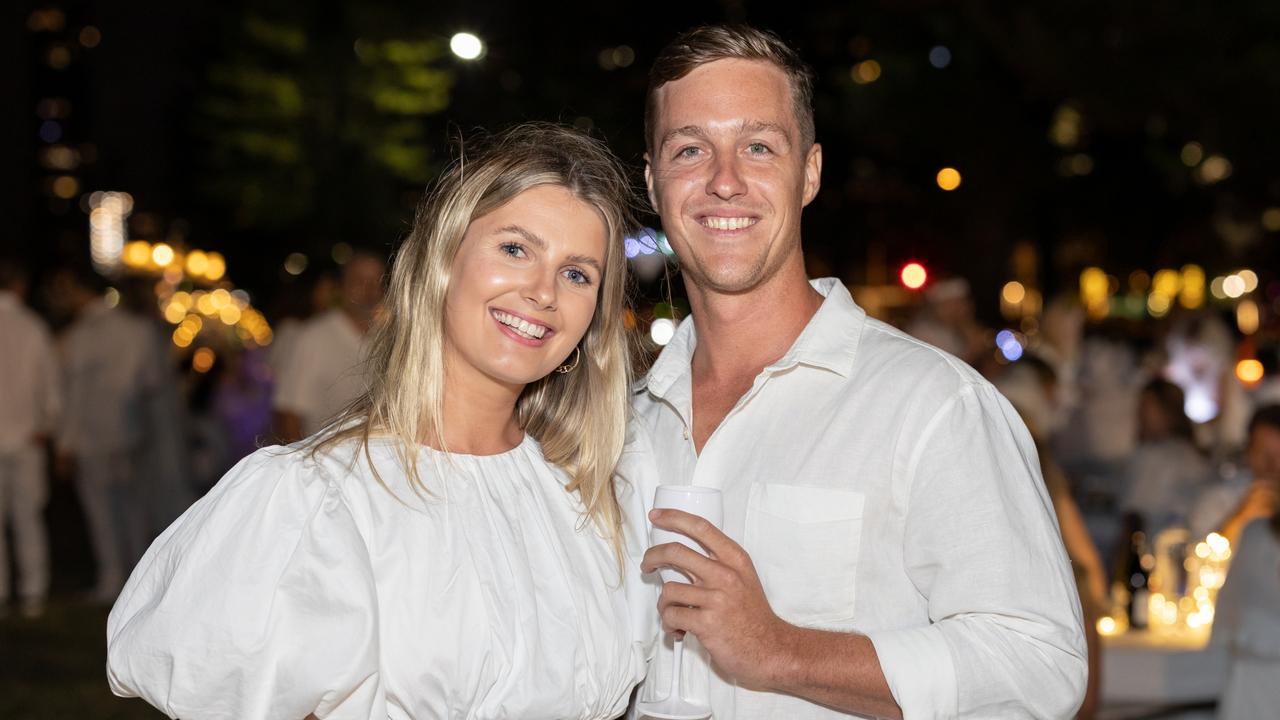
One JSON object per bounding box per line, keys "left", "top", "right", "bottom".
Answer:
{"left": 745, "top": 483, "right": 865, "bottom": 629}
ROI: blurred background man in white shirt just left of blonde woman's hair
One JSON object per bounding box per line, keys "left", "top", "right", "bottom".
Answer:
{"left": 275, "top": 251, "right": 387, "bottom": 442}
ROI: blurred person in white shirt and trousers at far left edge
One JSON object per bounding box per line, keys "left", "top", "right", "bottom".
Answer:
{"left": 0, "top": 258, "right": 61, "bottom": 616}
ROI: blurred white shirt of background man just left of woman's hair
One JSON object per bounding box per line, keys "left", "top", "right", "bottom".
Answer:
{"left": 274, "top": 310, "right": 366, "bottom": 436}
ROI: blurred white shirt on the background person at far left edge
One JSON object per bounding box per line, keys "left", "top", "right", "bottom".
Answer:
{"left": 0, "top": 291, "right": 61, "bottom": 454}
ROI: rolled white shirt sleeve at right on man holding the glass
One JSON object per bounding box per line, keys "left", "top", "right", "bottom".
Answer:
{"left": 869, "top": 384, "right": 1087, "bottom": 720}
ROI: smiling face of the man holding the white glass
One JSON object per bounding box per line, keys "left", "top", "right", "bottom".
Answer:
{"left": 645, "top": 60, "right": 822, "bottom": 293}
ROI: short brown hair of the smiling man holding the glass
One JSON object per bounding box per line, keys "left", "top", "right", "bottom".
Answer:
{"left": 644, "top": 24, "right": 815, "bottom": 154}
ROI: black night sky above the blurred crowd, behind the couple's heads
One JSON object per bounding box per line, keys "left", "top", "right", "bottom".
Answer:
{"left": 0, "top": 0, "right": 1280, "bottom": 315}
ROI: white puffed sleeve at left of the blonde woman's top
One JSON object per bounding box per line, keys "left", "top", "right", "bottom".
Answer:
{"left": 108, "top": 447, "right": 387, "bottom": 720}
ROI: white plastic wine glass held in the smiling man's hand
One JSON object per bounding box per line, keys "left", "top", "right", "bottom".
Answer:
{"left": 636, "top": 486, "right": 724, "bottom": 720}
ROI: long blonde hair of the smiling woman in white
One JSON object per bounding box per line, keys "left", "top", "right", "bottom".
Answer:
{"left": 310, "top": 123, "right": 635, "bottom": 552}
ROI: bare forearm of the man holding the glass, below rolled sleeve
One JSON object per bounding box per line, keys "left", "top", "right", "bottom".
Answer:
{"left": 763, "top": 625, "right": 902, "bottom": 717}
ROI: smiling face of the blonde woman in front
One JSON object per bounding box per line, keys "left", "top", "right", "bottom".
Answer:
{"left": 444, "top": 179, "right": 608, "bottom": 392}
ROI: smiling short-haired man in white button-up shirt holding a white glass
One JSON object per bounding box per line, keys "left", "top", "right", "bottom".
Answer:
{"left": 635, "top": 27, "right": 1085, "bottom": 719}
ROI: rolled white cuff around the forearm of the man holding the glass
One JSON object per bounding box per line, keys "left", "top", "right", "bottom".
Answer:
{"left": 867, "top": 625, "right": 959, "bottom": 720}
